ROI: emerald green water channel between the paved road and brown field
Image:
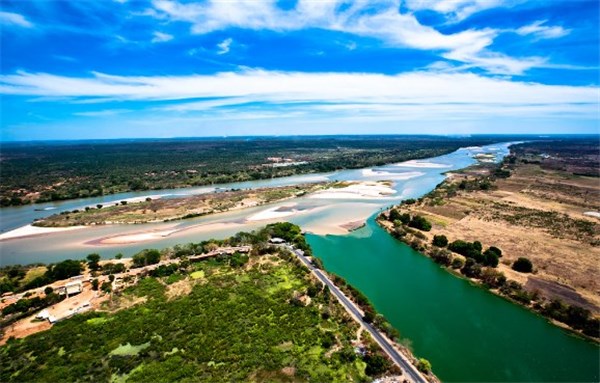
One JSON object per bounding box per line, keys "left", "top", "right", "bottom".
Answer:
{"left": 307, "top": 219, "right": 600, "bottom": 382}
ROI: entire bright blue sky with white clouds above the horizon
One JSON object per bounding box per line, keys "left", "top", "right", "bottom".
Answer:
{"left": 0, "top": 0, "right": 600, "bottom": 141}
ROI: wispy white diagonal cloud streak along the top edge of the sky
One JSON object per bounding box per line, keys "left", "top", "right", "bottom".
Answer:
{"left": 146, "top": 0, "right": 538, "bottom": 74}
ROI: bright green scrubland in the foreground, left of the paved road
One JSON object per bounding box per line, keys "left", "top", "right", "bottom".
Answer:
{"left": 0, "top": 223, "right": 429, "bottom": 382}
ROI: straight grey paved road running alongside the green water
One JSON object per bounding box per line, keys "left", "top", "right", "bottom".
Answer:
{"left": 286, "top": 246, "right": 427, "bottom": 383}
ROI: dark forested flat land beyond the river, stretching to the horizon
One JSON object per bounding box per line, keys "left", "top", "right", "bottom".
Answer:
{"left": 0, "top": 136, "right": 506, "bottom": 206}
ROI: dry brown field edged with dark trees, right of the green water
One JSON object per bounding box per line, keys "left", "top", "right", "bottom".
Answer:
{"left": 378, "top": 141, "right": 600, "bottom": 340}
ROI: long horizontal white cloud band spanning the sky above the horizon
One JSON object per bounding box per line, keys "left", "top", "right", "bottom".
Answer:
{"left": 0, "top": 70, "right": 599, "bottom": 121}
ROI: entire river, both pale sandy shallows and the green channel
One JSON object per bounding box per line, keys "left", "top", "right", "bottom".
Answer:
{"left": 0, "top": 144, "right": 599, "bottom": 382}
